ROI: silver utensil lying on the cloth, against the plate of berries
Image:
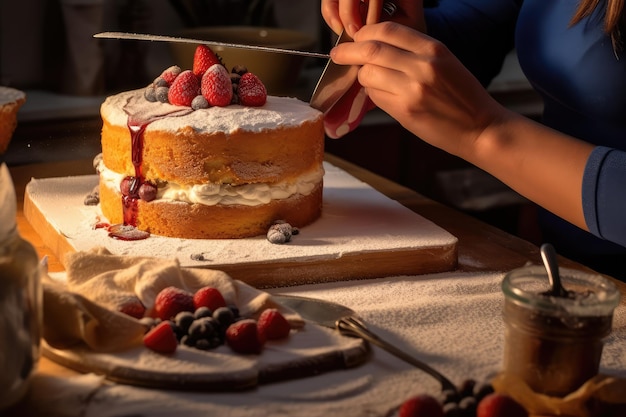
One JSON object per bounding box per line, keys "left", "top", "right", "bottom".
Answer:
{"left": 272, "top": 294, "right": 458, "bottom": 392}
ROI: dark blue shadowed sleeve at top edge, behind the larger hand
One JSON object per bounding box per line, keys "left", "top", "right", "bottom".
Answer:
{"left": 424, "top": 0, "right": 522, "bottom": 86}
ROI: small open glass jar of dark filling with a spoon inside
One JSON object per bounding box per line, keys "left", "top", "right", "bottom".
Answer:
{"left": 502, "top": 266, "right": 620, "bottom": 397}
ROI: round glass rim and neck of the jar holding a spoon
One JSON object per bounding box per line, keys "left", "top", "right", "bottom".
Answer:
{"left": 502, "top": 265, "right": 620, "bottom": 317}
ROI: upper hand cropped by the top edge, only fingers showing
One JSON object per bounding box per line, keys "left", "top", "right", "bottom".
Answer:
{"left": 322, "top": 0, "right": 426, "bottom": 36}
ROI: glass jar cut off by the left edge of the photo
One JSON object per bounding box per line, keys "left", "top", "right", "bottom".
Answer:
{"left": 0, "top": 164, "right": 43, "bottom": 410}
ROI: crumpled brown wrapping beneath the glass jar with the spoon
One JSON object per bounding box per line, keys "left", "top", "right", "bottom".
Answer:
{"left": 492, "top": 372, "right": 626, "bottom": 417}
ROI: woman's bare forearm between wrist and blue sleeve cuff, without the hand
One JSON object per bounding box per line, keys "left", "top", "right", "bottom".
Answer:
{"left": 468, "top": 111, "right": 594, "bottom": 230}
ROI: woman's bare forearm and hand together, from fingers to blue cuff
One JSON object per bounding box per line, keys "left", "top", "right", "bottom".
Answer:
{"left": 331, "top": 23, "right": 593, "bottom": 229}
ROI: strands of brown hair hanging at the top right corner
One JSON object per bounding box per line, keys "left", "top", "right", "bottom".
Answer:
{"left": 571, "top": 0, "right": 626, "bottom": 54}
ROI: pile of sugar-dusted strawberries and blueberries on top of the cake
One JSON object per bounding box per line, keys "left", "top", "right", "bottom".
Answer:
{"left": 144, "top": 45, "right": 267, "bottom": 110}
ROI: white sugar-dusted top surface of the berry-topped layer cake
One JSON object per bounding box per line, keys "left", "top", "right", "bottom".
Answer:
{"left": 100, "top": 90, "right": 322, "bottom": 133}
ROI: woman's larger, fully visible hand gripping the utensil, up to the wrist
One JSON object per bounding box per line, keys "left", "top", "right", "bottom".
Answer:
{"left": 331, "top": 22, "right": 506, "bottom": 155}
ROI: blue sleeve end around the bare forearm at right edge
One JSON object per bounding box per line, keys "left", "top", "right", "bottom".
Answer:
{"left": 582, "top": 146, "right": 626, "bottom": 246}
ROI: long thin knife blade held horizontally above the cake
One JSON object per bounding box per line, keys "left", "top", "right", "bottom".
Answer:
{"left": 93, "top": 32, "right": 330, "bottom": 59}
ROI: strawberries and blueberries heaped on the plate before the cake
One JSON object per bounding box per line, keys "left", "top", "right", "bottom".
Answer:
{"left": 119, "top": 287, "right": 291, "bottom": 354}
